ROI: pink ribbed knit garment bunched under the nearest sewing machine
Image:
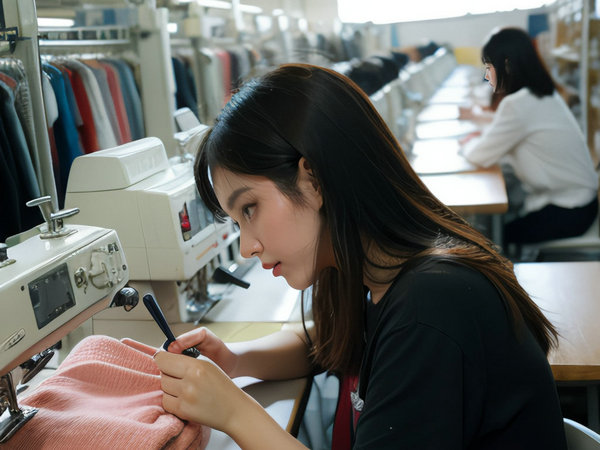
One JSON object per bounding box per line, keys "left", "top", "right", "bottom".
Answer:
{"left": 7, "top": 336, "right": 210, "bottom": 450}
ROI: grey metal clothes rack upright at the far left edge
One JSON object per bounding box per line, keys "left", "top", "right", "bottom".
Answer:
{"left": 0, "top": 0, "right": 58, "bottom": 211}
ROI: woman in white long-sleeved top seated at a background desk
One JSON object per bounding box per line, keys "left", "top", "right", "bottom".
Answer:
{"left": 462, "top": 28, "right": 598, "bottom": 244}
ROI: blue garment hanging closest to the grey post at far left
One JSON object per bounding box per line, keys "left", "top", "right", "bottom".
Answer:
{"left": 42, "top": 63, "right": 83, "bottom": 200}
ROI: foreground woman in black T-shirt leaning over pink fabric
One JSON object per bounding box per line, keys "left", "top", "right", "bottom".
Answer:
{"left": 156, "top": 65, "right": 566, "bottom": 449}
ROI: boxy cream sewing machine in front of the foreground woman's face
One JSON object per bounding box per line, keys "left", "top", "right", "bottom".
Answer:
{"left": 65, "top": 135, "right": 245, "bottom": 328}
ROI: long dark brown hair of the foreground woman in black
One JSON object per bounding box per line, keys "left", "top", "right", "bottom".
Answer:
{"left": 194, "top": 64, "right": 556, "bottom": 373}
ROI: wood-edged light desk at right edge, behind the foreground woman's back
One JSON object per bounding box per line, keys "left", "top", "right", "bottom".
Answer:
{"left": 515, "top": 261, "right": 600, "bottom": 432}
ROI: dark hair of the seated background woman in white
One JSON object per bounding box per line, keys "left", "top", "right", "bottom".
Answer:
{"left": 481, "top": 28, "right": 555, "bottom": 97}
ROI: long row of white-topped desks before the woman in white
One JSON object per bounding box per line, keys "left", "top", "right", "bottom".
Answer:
{"left": 408, "top": 68, "right": 508, "bottom": 229}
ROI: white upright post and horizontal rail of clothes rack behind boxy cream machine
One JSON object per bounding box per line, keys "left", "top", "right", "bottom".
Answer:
{"left": 39, "top": 4, "right": 178, "bottom": 157}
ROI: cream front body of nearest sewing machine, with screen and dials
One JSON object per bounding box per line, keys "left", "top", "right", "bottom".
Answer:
{"left": 0, "top": 225, "right": 129, "bottom": 375}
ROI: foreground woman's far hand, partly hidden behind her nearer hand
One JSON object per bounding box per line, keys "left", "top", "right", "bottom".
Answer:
{"left": 169, "top": 328, "right": 238, "bottom": 377}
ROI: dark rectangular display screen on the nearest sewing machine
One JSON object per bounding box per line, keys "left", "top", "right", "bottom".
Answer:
{"left": 29, "top": 263, "right": 75, "bottom": 329}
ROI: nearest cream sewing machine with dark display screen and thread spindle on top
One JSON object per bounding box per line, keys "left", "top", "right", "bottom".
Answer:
{"left": 0, "top": 197, "right": 131, "bottom": 443}
